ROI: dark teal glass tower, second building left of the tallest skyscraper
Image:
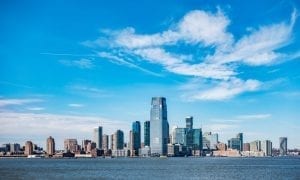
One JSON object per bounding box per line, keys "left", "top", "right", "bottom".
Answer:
{"left": 131, "top": 121, "right": 141, "bottom": 156}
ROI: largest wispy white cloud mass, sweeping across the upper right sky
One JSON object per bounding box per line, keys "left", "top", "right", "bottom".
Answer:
{"left": 83, "top": 8, "right": 299, "bottom": 100}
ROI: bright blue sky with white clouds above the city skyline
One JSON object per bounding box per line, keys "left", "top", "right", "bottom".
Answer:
{"left": 0, "top": 0, "right": 300, "bottom": 148}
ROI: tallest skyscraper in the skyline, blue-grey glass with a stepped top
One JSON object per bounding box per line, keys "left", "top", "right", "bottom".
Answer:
{"left": 150, "top": 97, "right": 169, "bottom": 155}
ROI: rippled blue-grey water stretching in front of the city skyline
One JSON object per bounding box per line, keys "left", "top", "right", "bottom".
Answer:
{"left": 0, "top": 157, "right": 300, "bottom": 180}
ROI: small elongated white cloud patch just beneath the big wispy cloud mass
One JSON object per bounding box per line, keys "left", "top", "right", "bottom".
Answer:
{"left": 184, "top": 78, "right": 261, "bottom": 101}
